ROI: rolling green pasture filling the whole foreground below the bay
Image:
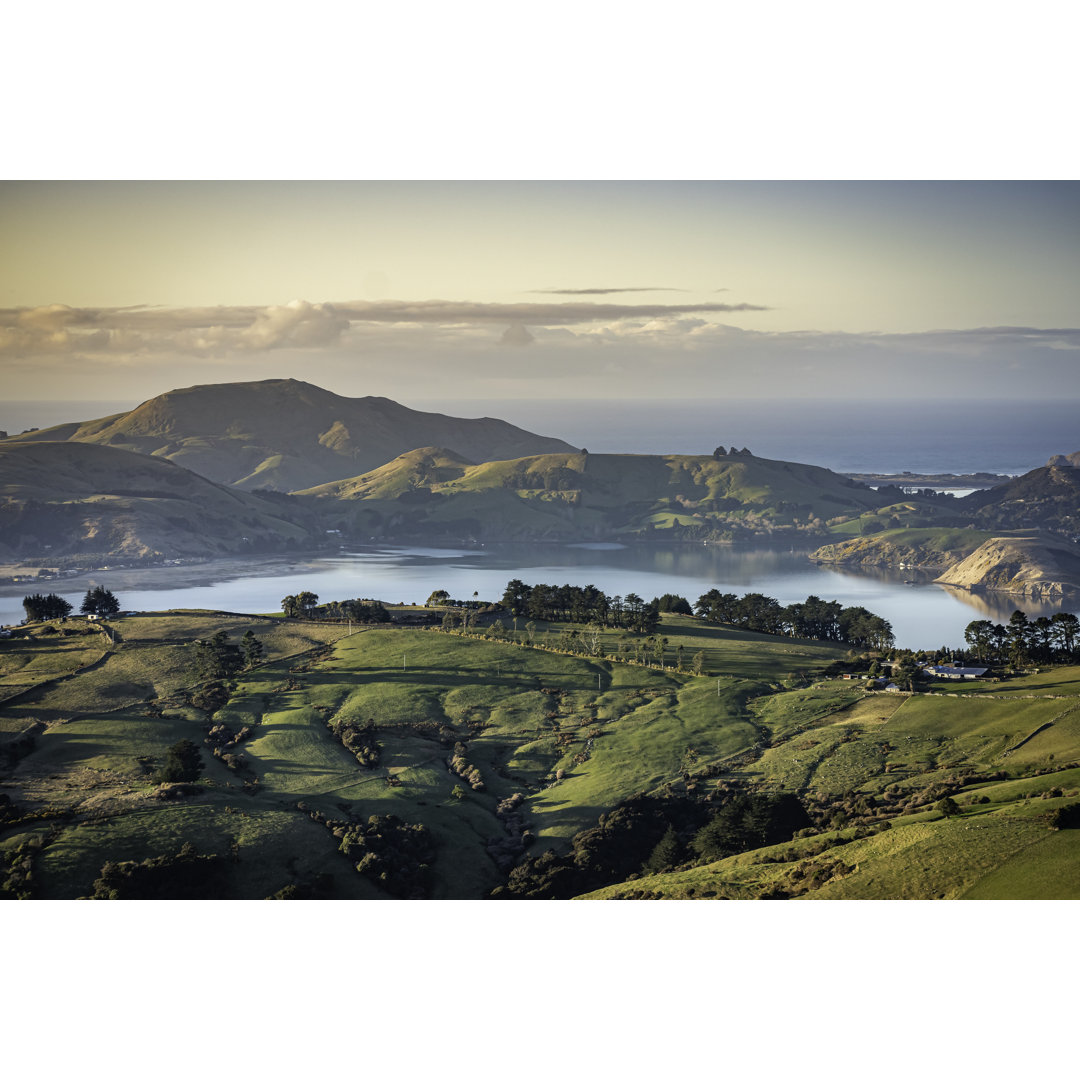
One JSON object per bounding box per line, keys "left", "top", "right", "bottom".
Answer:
{"left": 0, "top": 611, "right": 1080, "bottom": 899}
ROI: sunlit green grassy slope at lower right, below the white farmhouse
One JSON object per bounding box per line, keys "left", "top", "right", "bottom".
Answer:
{"left": 590, "top": 667, "right": 1080, "bottom": 900}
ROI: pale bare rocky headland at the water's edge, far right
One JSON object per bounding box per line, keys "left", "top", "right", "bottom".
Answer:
{"left": 936, "top": 537, "right": 1080, "bottom": 597}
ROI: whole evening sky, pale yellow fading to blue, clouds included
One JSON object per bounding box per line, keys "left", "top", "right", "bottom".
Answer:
{"left": 0, "top": 180, "right": 1080, "bottom": 411}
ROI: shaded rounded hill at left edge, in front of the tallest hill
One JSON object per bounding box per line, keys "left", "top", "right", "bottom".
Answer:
{"left": 0, "top": 442, "right": 320, "bottom": 558}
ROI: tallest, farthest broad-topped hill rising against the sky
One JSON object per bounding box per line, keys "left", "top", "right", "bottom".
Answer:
{"left": 8, "top": 379, "right": 571, "bottom": 491}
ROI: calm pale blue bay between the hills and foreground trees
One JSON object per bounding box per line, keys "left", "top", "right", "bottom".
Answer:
{"left": 0, "top": 543, "right": 1075, "bottom": 649}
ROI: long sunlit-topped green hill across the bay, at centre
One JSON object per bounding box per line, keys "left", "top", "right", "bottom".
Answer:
{"left": 296, "top": 446, "right": 887, "bottom": 541}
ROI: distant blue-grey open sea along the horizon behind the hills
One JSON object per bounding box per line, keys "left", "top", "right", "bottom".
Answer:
{"left": 0, "top": 397, "right": 1080, "bottom": 475}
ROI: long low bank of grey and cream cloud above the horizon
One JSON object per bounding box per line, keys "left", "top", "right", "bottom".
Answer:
{"left": 0, "top": 298, "right": 1080, "bottom": 400}
